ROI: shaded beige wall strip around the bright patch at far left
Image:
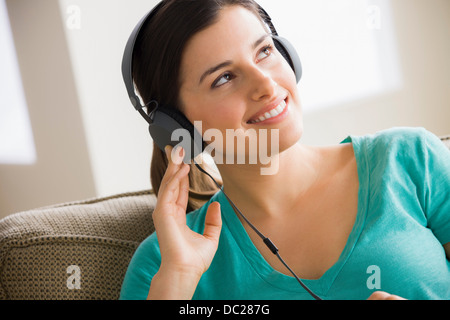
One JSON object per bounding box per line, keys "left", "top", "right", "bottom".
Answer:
{"left": 0, "top": 0, "right": 96, "bottom": 217}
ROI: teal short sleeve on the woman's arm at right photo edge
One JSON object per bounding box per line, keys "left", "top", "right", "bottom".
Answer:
{"left": 423, "top": 131, "right": 450, "bottom": 245}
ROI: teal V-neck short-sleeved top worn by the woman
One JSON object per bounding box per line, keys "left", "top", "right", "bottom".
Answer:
{"left": 121, "top": 128, "right": 450, "bottom": 300}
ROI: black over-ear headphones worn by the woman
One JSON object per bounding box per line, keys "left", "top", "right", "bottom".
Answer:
{"left": 122, "top": 0, "right": 302, "bottom": 163}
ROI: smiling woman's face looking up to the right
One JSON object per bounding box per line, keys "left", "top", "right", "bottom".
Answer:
{"left": 180, "top": 6, "right": 303, "bottom": 160}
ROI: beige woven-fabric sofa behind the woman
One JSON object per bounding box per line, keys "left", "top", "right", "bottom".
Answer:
{"left": 0, "top": 136, "right": 450, "bottom": 300}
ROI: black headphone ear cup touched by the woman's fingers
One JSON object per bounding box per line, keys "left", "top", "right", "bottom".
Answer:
{"left": 149, "top": 106, "right": 204, "bottom": 163}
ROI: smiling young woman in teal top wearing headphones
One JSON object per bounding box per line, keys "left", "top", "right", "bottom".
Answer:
{"left": 121, "top": 0, "right": 450, "bottom": 299}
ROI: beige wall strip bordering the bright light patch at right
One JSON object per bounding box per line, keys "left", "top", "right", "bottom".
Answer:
{"left": 298, "top": 0, "right": 450, "bottom": 144}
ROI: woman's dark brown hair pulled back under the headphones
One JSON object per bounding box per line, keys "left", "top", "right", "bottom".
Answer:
{"left": 133, "top": 0, "right": 265, "bottom": 212}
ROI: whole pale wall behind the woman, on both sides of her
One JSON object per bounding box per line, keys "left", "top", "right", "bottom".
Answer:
{"left": 0, "top": 0, "right": 450, "bottom": 216}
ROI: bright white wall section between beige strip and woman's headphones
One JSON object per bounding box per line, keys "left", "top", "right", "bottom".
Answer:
{"left": 59, "top": 0, "right": 157, "bottom": 196}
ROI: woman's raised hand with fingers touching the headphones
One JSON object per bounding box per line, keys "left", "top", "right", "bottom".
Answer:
{"left": 149, "top": 146, "right": 222, "bottom": 299}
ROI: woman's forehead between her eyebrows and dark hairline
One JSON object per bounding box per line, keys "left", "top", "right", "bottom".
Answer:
{"left": 181, "top": 5, "right": 268, "bottom": 79}
